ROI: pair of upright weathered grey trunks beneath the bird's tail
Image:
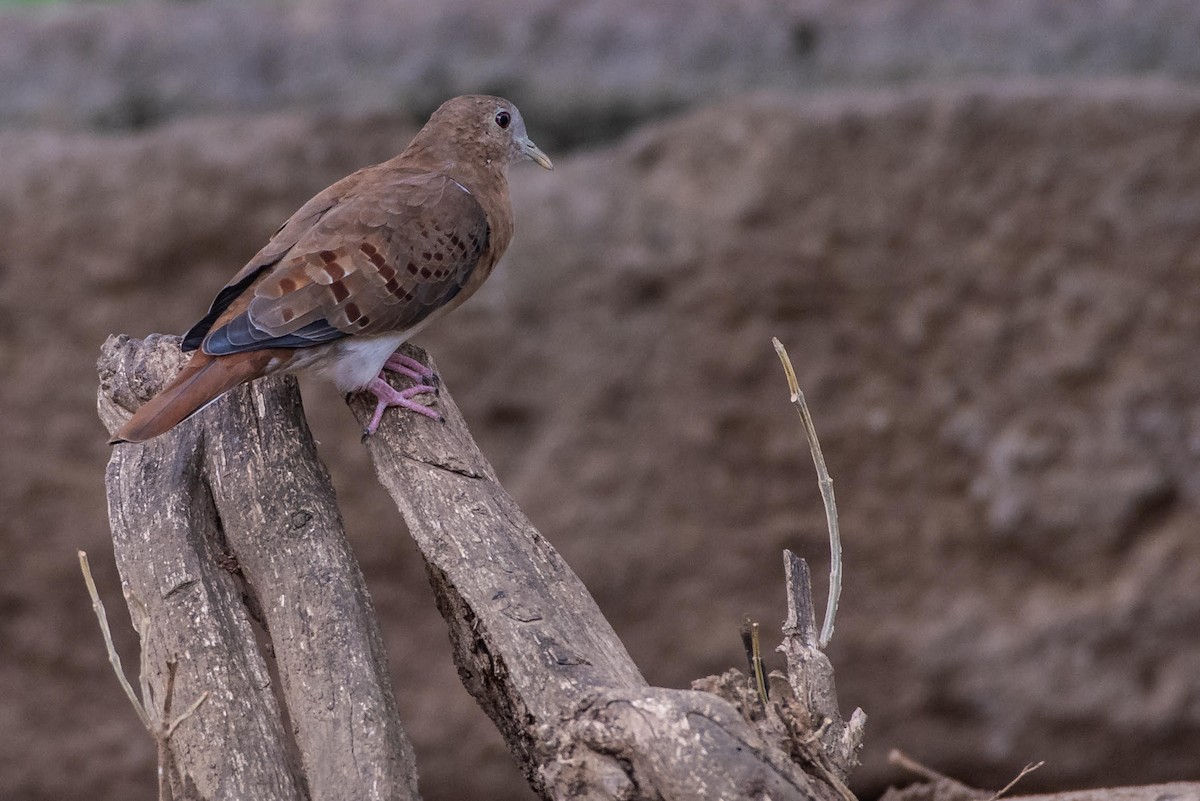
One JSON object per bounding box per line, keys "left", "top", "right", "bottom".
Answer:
{"left": 98, "top": 337, "right": 418, "bottom": 800}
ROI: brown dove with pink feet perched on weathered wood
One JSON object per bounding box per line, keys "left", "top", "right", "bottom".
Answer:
{"left": 113, "top": 95, "right": 553, "bottom": 442}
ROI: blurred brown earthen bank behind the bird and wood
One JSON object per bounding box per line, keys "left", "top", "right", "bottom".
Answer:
{"left": 0, "top": 0, "right": 1200, "bottom": 801}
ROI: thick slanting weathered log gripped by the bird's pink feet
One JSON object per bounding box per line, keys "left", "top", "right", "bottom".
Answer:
{"left": 352, "top": 349, "right": 842, "bottom": 800}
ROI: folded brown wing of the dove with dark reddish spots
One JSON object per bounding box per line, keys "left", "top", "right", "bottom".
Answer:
{"left": 196, "top": 169, "right": 488, "bottom": 355}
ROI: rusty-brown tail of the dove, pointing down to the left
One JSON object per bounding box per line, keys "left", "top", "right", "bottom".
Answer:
{"left": 108, "top": 350, "right": 271, "bottom": 445}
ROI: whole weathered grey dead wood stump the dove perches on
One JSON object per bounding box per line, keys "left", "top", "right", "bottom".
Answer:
{"left": 93, "top": 337, "right": 862, "bottom": 801}
